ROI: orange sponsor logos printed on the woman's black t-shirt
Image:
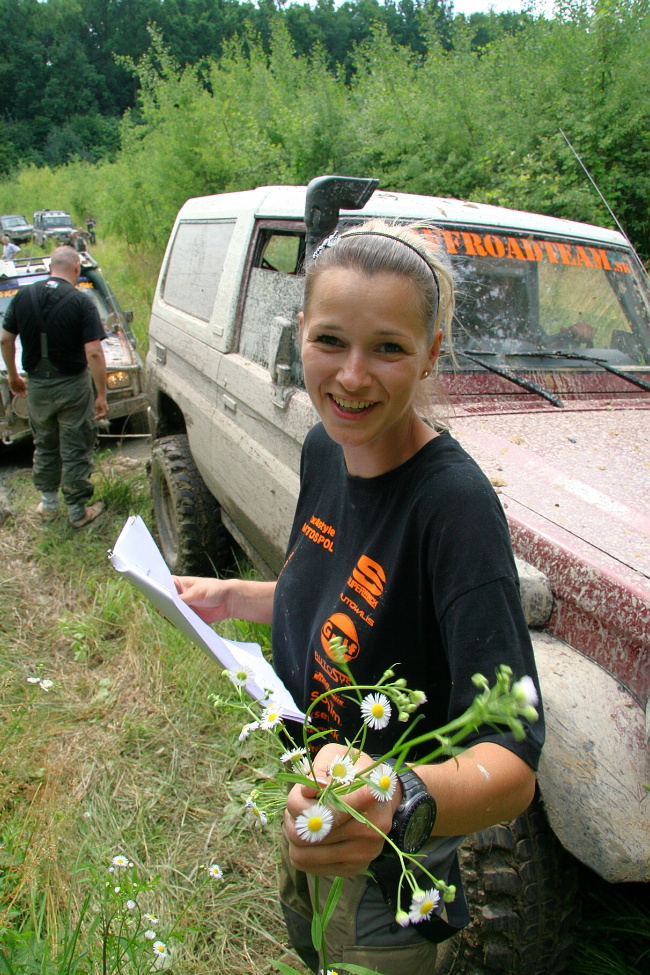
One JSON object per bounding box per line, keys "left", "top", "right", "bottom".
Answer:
{"left": 302, "top": 515, "right": 386, "bottom": 741}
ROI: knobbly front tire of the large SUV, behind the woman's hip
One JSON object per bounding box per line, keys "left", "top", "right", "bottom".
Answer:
{"left": 436, "top": 798, "right": 579, "bottom": 975}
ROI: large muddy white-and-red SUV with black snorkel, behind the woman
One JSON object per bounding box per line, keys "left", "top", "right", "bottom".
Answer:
{"left": 147, "top": 177, "right": 650, "bottom": 975}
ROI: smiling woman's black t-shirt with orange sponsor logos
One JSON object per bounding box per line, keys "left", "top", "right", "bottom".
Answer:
{"left": 273, "top": 424, "right": 544, "bottom": 768}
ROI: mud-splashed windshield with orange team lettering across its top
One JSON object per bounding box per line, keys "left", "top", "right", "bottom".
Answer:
{"left": 416, "top": 228, "right": 650, "bottom": 368}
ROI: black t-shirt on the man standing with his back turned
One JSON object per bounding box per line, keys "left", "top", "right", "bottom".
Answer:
{"left": 3, "top": 277, "right": 106, "bottom": 376}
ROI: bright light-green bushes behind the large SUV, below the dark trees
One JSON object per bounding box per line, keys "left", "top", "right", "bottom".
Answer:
{"left": 0, "top": 0, "right": 650, "bottom": 258}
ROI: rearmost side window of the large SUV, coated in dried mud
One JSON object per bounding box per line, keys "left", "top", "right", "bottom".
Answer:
{"left": 162, "top": 220, "right": 235, "bottom": 322}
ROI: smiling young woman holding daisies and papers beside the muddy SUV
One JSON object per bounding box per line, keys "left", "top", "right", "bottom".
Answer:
{"left": 177, "top": 221, "right": 543, "bottom": 975}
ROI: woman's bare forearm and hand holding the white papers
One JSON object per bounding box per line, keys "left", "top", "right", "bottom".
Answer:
{"left": 173, "top": 576, "right": 275, "bottom": 623}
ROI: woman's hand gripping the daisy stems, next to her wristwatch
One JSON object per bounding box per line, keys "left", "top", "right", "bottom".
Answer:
{"left": 284, "top": 744, "right": 402, "bottom": 877}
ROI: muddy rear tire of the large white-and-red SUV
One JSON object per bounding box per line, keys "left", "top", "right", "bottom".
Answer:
{"left": 151, "top": 434, "right": 233, "bottom": 575}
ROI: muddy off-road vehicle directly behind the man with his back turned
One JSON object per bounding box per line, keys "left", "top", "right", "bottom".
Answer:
{"left": 0, "top": 254, "right": 147, "bottom": 444}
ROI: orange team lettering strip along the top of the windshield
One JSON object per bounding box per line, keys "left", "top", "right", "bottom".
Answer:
{"left": 418, "top": 228, "right": 632, "bottom": 274}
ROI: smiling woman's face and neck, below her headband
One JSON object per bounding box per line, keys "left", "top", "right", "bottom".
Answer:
{"left": 300, "top": 268, "right": 442, "bottom": 477}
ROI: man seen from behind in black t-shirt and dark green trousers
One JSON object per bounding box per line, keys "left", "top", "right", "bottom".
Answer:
{"left": 0, "top": 245, "right": 108, "bottom": 528}
